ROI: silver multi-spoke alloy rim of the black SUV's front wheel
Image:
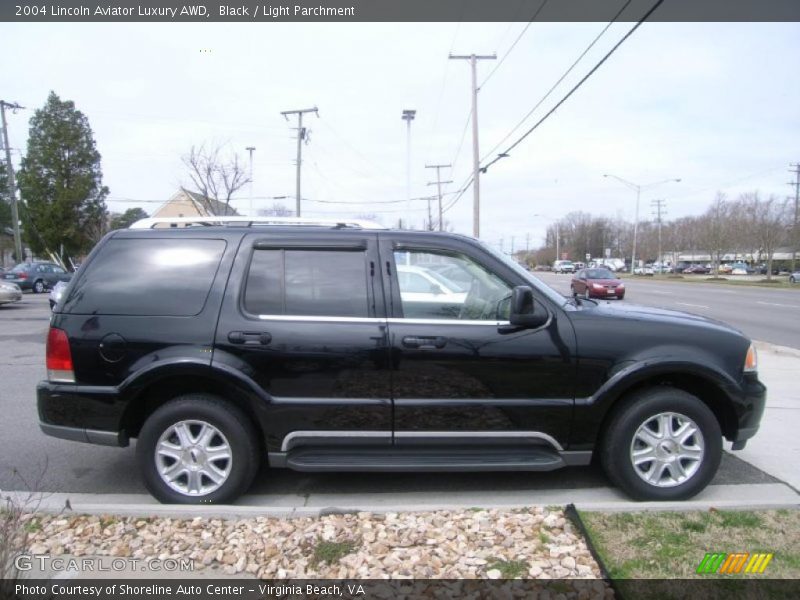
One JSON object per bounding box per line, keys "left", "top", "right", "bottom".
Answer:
{"left": 630, "top": 412, "right": 705, "bottom": 488}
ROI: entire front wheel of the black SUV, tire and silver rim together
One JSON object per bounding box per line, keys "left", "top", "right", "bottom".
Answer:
{"left": 600, "top": 387, "right": 722, "bottom": 500}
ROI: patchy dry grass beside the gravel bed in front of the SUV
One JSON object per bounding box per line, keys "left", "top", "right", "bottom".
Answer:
{"left": 581, "top": 509, "right": 800, "bottom": 580}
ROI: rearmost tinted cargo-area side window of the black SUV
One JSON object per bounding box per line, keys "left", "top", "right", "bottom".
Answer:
{"left": 63, "top": 238, "right": 225, "bottom": 317}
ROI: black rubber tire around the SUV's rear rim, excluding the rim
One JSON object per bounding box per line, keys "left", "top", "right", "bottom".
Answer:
{"left": 136, "top": 394, "right": 259, "bottom": 504}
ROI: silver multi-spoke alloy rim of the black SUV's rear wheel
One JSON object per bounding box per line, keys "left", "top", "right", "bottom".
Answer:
{"left": 155, "top": 421, "right": 233, "bottom": 496}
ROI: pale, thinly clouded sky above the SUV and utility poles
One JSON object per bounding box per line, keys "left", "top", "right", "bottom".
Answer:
{"left": 0, "top": 22, "right": 800, "bottom": 251}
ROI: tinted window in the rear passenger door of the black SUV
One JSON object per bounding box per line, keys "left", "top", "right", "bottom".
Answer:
{"left": 244, "top": 249, "right": 369, "bottom": 317}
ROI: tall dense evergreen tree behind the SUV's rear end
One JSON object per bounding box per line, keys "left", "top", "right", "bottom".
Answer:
{"left": 17, "top": 92, "right": 108, "bottom": 256}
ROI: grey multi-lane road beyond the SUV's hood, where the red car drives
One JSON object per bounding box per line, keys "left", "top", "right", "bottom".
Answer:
{"left": 535, "top": 272, "right": 800, "bottom": 348}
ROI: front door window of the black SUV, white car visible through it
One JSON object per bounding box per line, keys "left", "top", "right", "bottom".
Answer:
{"left": 394, "top": 250, "right": 511, "bottom": 321}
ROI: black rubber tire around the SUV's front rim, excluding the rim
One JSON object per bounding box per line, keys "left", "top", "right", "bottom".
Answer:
{"left": 601, "top": 387, "right": 722, "bottom": 500}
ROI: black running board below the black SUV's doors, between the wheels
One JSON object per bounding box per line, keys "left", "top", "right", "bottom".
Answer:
{"left": 282, "top": 446, "right": 573, "bottom": 472}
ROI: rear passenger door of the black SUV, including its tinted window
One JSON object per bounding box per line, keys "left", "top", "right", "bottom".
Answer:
{"left": 212, "top": 232, "right": 391, "bottom": 452}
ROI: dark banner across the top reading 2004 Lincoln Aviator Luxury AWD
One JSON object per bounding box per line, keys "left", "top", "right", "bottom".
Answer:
{"left": 0, "top": 0, "right": 800, "bottom": 23}
